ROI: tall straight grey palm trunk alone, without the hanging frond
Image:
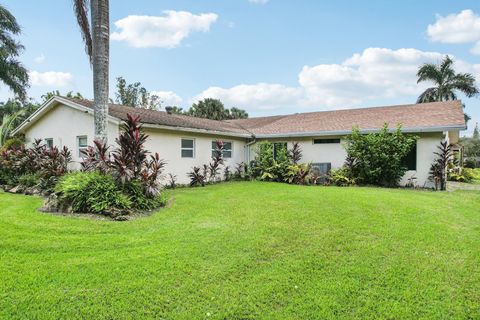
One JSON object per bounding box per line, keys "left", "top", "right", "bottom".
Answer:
{"left": 90, "top": 0, "right": 110, "bottom": 143}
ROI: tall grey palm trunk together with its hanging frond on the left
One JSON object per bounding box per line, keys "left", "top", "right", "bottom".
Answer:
{"left": 73, "top": 0, "right": 110, "bottom": 143}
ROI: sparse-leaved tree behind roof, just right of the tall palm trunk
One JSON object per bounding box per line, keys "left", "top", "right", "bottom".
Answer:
{"left": 115, "top": 77, "right": 161, "bottom": 110}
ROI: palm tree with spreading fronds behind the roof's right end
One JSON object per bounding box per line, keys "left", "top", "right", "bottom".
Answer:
{"left": 417, "top": 56, "right": 479, "bottom": 103}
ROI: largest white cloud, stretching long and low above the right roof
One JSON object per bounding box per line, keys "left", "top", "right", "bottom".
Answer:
{"left": 195, "top": 48, "right": 480, "bottom": 112}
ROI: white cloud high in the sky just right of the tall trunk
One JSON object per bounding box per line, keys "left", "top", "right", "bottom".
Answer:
{"left": 111, "top": 10, "right": 218, "bottom": 48}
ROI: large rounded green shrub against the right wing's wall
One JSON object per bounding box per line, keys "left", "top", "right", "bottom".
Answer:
{"left": 346, "top": 124, "right": 416, "bottom": 187}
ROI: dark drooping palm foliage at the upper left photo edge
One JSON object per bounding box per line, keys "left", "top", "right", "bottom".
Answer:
{"left": 0, "top": 5, "right": 28, "bottom": 100}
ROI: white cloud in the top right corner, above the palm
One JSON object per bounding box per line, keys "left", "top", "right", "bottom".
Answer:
{"left": 427, "top": 9, "right": 480, "bottom": 54}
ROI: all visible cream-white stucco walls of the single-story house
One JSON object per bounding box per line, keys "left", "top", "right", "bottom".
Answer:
{"left": 20, "top": 105, "right": 452, "bottom": 187}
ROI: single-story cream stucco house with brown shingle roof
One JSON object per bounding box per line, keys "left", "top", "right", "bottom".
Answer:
{"left": 15, "top": 97, "right": 466, "bottom": 186}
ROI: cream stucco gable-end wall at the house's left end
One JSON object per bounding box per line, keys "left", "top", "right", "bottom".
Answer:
{"left": 25, "top": 104, "right": 118, "bottom": 168}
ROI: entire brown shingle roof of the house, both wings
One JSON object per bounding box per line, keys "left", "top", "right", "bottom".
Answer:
{"left": 63, "top": 98, "right": 465, "bottom": 137}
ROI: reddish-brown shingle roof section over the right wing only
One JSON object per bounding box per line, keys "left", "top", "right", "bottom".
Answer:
{"left": 228, "top": 101, "right": 465, "bottom": 136}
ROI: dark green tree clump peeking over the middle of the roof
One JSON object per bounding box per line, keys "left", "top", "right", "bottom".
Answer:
{"left": 186, "top": 98, "right": 248, "bottom": 120}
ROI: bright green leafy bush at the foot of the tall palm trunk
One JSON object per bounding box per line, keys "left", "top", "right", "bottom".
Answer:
{"left": 55, "top": 172, "right": 132, "bottom": 213}
